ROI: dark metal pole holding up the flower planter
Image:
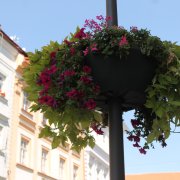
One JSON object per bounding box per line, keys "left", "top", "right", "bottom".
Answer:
{"left": 106, "top": 0, "right": 125, "bottom": 180}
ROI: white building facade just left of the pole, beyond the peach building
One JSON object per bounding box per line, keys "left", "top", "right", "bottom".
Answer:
{"left": 84, "top": 128, "right": 109, "bottom": 180}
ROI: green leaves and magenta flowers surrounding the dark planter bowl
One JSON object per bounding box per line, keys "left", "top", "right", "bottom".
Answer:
{"left": 23, "top": 16, "right": 180, "bottom": 151}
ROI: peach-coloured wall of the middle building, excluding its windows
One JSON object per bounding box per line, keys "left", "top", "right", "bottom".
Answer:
{"left": 9, "top": 55, "right": 84, "bottom": 180}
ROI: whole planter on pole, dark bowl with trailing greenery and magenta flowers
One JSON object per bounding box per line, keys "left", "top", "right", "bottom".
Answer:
{"left": 24, "top": 16, "right": 180, "bottom": 153}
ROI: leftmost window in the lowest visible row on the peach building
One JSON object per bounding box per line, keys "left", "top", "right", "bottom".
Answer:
{"left": 20, "top": 138, "right": 29, "bottom": 164}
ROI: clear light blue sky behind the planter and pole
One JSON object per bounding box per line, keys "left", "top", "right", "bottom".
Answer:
{"left": 0, "top": 0, "right": 180, "bottom": 174}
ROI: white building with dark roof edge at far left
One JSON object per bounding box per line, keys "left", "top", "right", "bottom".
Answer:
{"left": 0, "top": 29, "right": 25, "bottom": 179}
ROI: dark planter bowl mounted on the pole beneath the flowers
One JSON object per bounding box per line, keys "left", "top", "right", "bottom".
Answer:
{"left": 86, "top": 50, "right": 156, "bottom": 108}
